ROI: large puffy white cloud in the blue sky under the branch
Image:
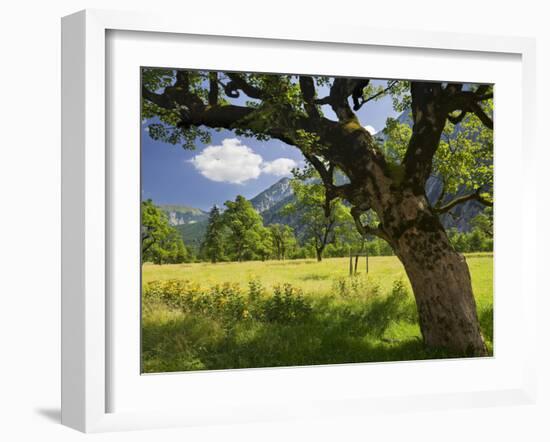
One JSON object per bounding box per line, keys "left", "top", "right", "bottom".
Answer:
{"left": 189, "top": 138, "right": 298, "bottom": 184}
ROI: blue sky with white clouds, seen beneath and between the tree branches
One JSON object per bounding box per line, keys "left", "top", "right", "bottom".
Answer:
{"left": 141, "top": 81, "right": 397, "bottom": 210}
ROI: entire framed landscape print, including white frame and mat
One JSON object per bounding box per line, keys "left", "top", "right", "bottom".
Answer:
{"left": 62, "top": 11, "right": 536, "bottom": 431}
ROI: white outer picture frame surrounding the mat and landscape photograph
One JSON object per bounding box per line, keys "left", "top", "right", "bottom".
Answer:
{"left": 62, "top": 10, "right": 536, "bottom": 432}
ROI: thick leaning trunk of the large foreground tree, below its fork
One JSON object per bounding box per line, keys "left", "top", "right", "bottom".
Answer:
{"left": 390, "top": 195, "right": 487, "bottom": 356}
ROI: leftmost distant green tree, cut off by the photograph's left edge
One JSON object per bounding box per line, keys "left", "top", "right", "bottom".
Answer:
{"left": 141, "top": 199, "right": 188, "bottom": 265}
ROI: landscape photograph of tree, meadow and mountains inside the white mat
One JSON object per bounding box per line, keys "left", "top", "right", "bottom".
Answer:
{"left": 141, "top": 66, "right": 494, "bottom": 374}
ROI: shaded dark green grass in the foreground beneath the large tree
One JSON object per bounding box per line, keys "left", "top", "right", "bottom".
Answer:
{"left": 142, "top": 292, "right": 484, "bottom": 373}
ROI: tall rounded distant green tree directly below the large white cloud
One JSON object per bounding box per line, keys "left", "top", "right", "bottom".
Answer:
{"left": 223, "top": 195, "right": 268, "bottom": 261}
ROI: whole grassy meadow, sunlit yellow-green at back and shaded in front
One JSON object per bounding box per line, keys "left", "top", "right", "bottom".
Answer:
{"left": 142, "top": 253, "right": 493, "bottom": 373}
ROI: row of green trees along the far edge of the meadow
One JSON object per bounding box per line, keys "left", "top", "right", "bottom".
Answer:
{"left": 142, "top": 178, "right": 493, "bottom": 264}
